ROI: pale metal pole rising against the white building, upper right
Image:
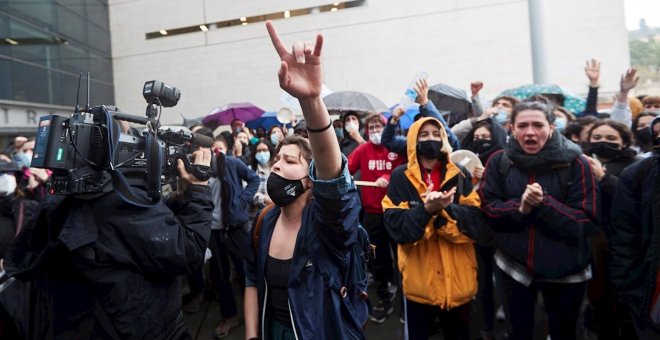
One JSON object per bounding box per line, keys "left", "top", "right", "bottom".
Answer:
{"left": 528, "top": 0, "right": 548, "bottom": 84}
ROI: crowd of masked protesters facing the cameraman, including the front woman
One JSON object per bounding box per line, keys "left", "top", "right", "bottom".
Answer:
{"left": 0, "top": 24, "right": 660, "bottom": 339}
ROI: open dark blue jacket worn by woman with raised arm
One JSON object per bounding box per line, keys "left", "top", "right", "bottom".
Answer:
{"left": 245, "top": 155, "right": 366, "bottom": 340}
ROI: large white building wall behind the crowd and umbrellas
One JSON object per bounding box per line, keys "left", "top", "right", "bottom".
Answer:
{"left": 109, "top": 0, "right": 630, "bottom": 123}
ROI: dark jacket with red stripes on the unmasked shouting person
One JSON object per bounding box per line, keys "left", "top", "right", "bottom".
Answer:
{"left": 479, "top": 133, "right": 599, "bottom": 279}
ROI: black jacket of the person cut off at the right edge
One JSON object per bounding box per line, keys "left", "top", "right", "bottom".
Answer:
{"left": 610, "top": 155, "right": 660, "bottom": 319}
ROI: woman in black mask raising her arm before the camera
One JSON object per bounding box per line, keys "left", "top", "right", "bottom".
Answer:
{"left": 245, "top": 21, "right": 368, "bottom": 339}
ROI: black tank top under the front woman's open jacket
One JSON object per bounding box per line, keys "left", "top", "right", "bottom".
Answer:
{"left": 266, "top": 255, "right": 293, "bottom": 327}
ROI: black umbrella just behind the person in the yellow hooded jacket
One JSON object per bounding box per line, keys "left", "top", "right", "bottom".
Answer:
{"left": 429, "top": 83, "right": 472, "bottom": 126}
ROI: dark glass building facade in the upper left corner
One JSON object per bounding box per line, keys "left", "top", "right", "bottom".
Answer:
{"left": 0, "top": 0, "right": 114, "bottom": 107}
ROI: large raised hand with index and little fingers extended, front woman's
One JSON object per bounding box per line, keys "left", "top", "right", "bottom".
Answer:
{"left": 266, "top": 20, "right": 323, "bottom": 99}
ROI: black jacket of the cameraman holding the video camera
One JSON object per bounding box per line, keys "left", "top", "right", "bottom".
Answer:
{"left": 5, "top": 185, "right": 213, "bottom": 339}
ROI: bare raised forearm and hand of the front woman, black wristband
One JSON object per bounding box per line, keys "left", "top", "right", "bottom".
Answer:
{"left": 266, "top": 20, "right": 342, "bottom": 179}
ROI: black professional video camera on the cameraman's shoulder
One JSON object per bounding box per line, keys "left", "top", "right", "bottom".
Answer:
{"left": 31, "top": 81, "right": 213, "bottom": 195}
